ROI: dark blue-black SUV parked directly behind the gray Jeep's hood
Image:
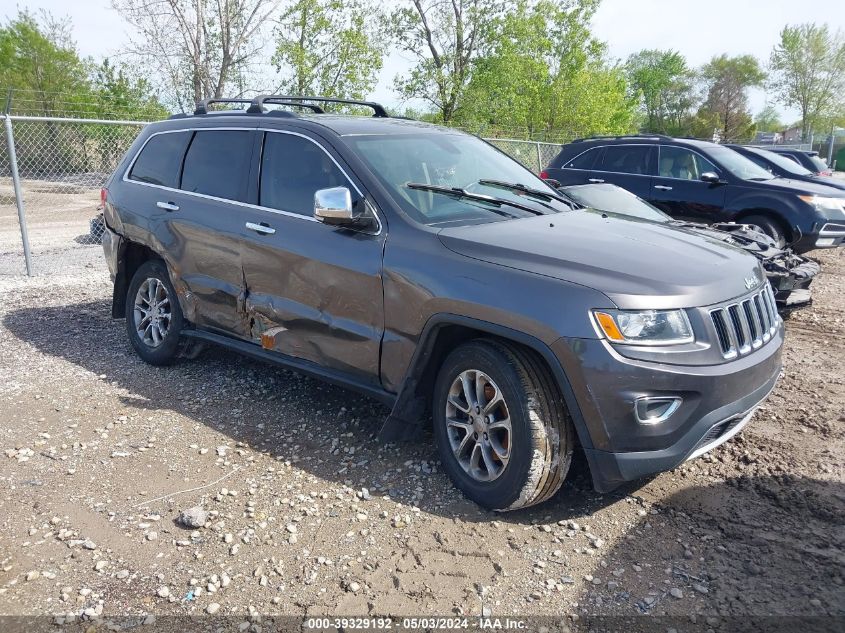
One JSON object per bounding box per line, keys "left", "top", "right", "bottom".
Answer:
{"left": 541, "top": 135, "right": 845, "bottom": 253}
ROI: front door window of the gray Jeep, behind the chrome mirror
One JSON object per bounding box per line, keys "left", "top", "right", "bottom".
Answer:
{"left": 258, "top": 132, "right": 349, "bottom": 215}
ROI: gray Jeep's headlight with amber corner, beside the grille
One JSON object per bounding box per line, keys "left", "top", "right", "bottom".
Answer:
{"left": 593, "top": 310, "right": 695, "bottom": 345}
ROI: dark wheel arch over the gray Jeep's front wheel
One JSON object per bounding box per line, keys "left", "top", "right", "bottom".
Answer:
{"left": 379, "top": 313, "right": 593, "bottom": 448}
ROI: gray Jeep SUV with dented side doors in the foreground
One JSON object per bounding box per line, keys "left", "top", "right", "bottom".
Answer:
{"left": 103, "top": 96, "right": 783, "bottom": 510}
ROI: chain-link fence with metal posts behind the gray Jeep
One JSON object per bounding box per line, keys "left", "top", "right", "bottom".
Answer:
{"left": 0, "top": 115, "right": 561, "bottom": 275}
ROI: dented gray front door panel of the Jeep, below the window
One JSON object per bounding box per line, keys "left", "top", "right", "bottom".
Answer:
{"left": 240, "top": 209, "right": 384, "bottom": 383}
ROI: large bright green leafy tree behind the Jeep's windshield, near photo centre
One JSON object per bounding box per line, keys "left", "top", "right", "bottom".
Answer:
{"left": 458, "top": 0, "right": 633, "bottom": 138}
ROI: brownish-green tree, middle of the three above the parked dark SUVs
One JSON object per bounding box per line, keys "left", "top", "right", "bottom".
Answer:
{"left": 694, "top": 54, "right": 766, "bottom": 141}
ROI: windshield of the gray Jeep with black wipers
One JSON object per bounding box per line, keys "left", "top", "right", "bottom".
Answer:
{"left": 344, "top": 132, "right": 570, "bottom": 226}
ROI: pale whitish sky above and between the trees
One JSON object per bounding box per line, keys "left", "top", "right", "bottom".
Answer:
{"left": 6, "top": 0, "right": 845, "bottom": 119}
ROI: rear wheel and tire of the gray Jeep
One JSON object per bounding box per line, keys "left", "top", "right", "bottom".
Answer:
{"left": 126, "top": 260, "right": 185, "bottom": 365}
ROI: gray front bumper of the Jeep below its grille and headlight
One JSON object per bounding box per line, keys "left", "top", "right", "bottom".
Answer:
{"left": 554, "top": 326, "right": 783, "bottom": 492}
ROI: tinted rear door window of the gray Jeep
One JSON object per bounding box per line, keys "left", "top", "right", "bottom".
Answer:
{"left": 181, "top": 130, "right": 253, "bottom": 202}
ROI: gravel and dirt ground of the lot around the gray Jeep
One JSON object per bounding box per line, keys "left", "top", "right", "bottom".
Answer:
{"left": 0, "top": 250, "right": 845, "bottom": 622}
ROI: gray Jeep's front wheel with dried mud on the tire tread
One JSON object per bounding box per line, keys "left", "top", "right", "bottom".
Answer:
{"left": 433, "top": 339, "right": 574, "bottom": 510}
